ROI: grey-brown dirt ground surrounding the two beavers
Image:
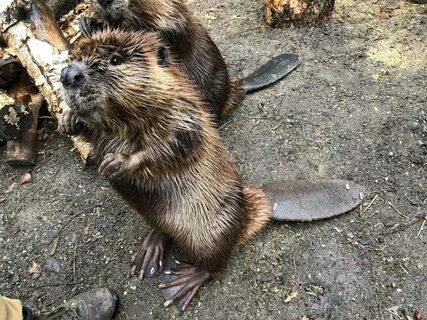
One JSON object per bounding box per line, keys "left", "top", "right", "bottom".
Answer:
{"left": 0, "top": 0, "right": 427, "bottom": 320}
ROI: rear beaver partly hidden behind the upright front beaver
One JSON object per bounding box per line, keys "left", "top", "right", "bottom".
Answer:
{"left": 80, "top": 0, "right": 299, "bottom": 122}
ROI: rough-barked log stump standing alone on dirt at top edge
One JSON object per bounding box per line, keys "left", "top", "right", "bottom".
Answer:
{"left": 264, "top": 0, "right": 335, "bottom": 27}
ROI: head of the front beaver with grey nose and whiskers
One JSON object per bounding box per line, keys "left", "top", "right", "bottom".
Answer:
{"left": 61, "top": 29, "right": 172, "bottom": 129}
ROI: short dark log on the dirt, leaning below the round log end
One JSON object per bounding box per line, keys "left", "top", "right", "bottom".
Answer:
{"left": 6, "top": 94, "right": 45, "bottom": 167}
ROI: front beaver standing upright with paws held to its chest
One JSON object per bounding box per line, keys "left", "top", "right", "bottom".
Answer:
{"left": 61, "top": 29, "right": 362, "bottom": 310}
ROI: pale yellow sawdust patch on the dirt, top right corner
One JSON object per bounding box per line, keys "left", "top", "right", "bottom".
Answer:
{"left": 334, "top": 0, "right": 427, "bottom": 71}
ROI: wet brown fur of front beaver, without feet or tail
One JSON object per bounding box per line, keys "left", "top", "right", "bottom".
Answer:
{"left": 66, "top": 30, "right": 271, "bottom": 272}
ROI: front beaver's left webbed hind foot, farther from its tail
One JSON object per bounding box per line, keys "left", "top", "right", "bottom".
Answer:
{"left": 131, "top": 230, "right": 167, "bottom": 280}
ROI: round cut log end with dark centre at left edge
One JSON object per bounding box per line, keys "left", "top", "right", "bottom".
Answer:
{"left": 0, "top": 90, "right": 33, "bottom": 140}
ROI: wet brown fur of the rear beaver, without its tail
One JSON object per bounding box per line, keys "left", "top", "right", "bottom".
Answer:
{"left": 88, "top": 0, "right": 245, "bottom": 121}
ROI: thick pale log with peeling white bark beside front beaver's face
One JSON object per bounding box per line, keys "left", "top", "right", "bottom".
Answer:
{"left": 0, "top": 0, "right": 69, "bottom": 117}
